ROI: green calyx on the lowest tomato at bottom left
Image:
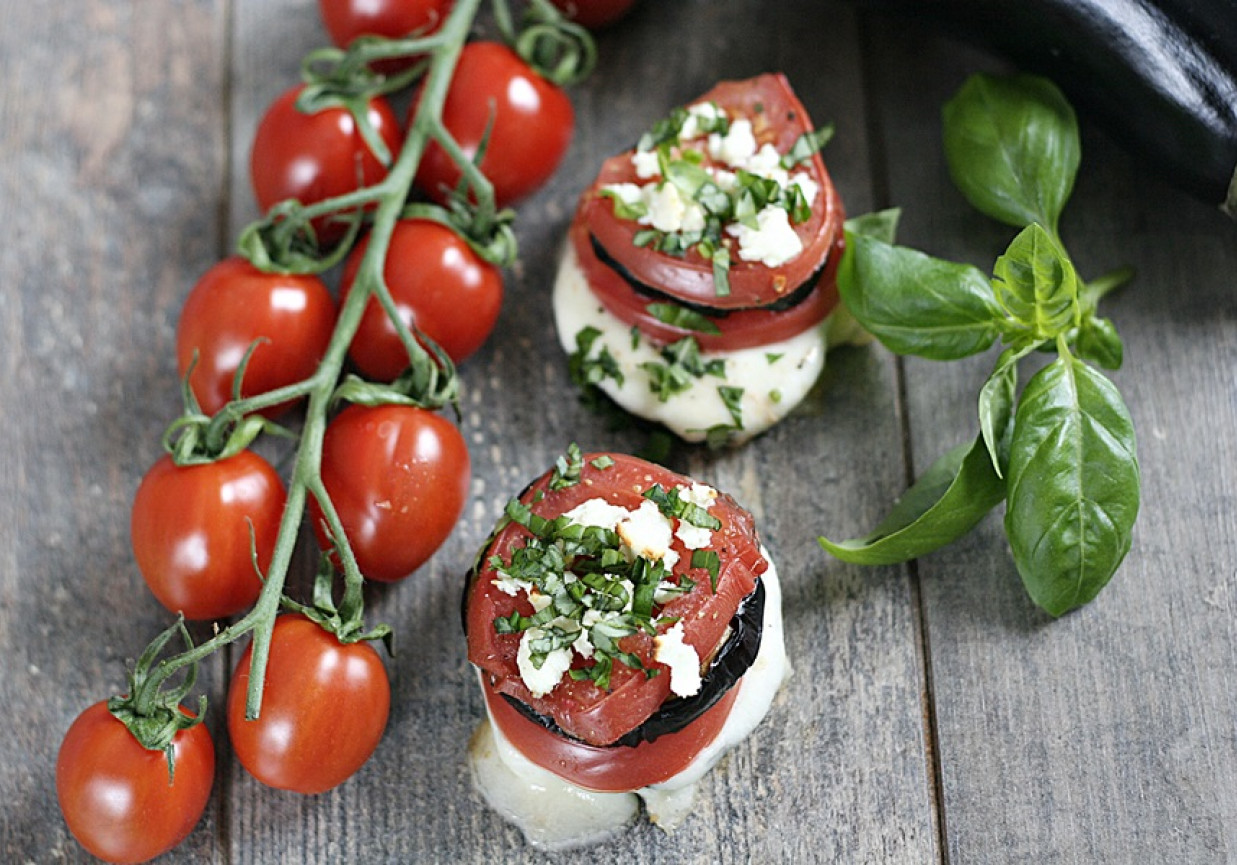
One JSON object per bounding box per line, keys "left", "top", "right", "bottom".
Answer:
{"left": 108, "top": 616, "right": 207, "bottom": 783}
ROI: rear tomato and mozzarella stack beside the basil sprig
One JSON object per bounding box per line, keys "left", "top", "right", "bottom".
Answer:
{"left": 554, "top": 74, "right": 844, "bottom": 444}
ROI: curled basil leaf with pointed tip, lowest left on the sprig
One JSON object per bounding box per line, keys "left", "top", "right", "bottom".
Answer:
{"left": 818, "top": 438, "right": 1004, "bottom": 564}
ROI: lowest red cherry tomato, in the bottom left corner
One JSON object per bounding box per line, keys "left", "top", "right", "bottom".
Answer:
{"left": 56, "top": 702, "right": 215, "bottom": 863}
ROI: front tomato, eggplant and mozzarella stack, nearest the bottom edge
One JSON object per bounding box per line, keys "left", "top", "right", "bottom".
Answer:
{"left": 464, "top": 447, "right": 789, "bottom": 848}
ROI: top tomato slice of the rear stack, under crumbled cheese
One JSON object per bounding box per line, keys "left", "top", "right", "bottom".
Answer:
{"left": 580, "top": 74, "right": 844, "bottom": 309}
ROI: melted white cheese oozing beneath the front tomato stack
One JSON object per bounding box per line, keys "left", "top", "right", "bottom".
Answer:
{"left": 469, "top": 549, "right": 790, "bottom": 851}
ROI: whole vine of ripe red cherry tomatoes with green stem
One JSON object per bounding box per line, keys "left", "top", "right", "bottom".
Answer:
{"left": 57, "top": 0, "right": 638, "bottom": 863}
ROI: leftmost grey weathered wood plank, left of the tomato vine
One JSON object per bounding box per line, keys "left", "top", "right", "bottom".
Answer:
{"left": 0, "top": 0, "right": 232, "bottom": 863}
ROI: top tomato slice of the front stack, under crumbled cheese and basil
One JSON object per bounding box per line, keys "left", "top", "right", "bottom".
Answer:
{"left": 465, "top": 454, "right": 768, "bottom": 745}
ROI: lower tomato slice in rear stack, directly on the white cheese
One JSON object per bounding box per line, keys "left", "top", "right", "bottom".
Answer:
{"left": 569, "top": 210, "right": 845, "bottom": 351}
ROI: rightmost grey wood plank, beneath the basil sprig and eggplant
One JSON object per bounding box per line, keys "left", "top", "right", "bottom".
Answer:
{"left": 875, "top": 22, "right": 1237, "bottom": 865}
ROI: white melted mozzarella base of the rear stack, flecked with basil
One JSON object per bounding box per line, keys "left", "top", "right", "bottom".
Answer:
{"left": 554, "top": 244, "right": 829, "bottom": 444}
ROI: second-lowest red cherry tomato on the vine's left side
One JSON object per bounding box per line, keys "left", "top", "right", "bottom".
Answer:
{"left": 130, "top": 450, "right": 286, "bottom": 619}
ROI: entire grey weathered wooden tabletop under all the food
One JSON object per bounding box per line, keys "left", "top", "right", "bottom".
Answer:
{"left": 0, "top": 0, "right": 1237, "bottom": 865}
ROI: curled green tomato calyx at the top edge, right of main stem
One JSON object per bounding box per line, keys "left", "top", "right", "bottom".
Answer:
{"left": 494, "top": 0, "right": 597, "bottom": 87}
